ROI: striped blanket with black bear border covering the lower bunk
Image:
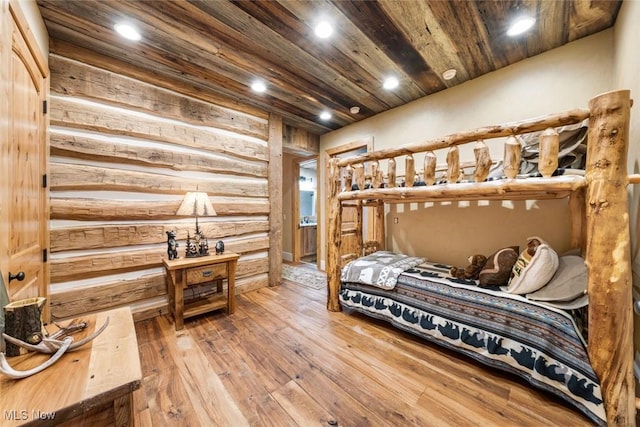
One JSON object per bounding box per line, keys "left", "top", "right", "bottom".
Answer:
{"left": 340, "top": 263, "right": 606, "bottom": 425}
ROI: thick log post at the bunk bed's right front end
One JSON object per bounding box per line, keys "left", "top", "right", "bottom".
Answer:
{"left": 585, "top": 90, "right": 635, "bottom": 425}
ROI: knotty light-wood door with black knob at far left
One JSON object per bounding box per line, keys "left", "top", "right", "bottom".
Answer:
{"left": 0, "top": 2, "right": 49, "bottom": 320}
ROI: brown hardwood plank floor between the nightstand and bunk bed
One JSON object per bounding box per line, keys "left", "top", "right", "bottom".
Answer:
{"left": 134, "top": 282, "right": 590, "bottom": 427}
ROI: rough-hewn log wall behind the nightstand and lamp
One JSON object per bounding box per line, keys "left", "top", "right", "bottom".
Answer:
{"left": 49, "top": 55, "right": 274, "bottom": 320}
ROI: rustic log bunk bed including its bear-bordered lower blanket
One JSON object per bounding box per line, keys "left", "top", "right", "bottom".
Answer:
{"left": 327, "top": 90, "right": 640, "bottom": 425}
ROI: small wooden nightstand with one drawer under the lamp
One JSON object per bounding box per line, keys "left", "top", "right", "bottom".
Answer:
{"left": 162, "top": 252, "right": 240, "bottom": 331}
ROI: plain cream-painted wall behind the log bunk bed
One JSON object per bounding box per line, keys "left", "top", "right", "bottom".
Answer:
{"left": 318, "top": 29, "right": 614, "bottom": 265}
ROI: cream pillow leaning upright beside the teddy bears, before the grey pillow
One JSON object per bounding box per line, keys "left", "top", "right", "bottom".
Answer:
{"left": 506, "top": 237, "right": 559, "bottom": 295}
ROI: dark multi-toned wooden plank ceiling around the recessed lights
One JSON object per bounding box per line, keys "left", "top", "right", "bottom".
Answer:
{"left": 37, "top": 0, "right": 621, "bottom": 134}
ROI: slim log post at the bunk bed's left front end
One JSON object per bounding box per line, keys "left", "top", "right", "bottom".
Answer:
{"left": 327, "top": 158, "right": 342, "bottom": 311}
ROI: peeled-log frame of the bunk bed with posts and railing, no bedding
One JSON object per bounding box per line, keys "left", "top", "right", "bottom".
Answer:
{"left": 326, "top": 90, "right": 640, "bottom": 425}
